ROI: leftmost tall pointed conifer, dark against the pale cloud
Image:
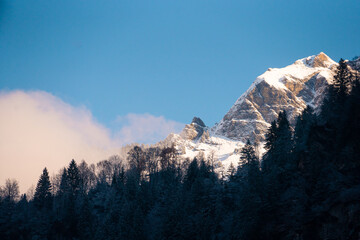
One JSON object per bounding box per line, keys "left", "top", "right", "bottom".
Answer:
{"left": 34, "top": 168, "right": 52, "bottom": 208}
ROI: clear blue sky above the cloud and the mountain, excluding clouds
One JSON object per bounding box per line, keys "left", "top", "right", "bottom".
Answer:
{"left": 0, "top": 0, "right": 360, "bottom": 128}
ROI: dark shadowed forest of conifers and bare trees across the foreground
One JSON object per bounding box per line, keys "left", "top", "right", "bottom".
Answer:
{"left": 0, "top": 60, "right": 360, "bottom": 240}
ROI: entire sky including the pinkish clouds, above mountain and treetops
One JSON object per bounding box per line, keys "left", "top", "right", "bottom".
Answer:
{"left": 0, "top": 0, "right": 360, "bottom": 191}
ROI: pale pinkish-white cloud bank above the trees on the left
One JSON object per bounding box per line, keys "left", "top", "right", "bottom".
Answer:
{"left": 0, "top": 91, "right": 181, "bottom": 192}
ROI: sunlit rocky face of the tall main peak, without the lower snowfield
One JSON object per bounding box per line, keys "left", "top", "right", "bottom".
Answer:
{"left": 212, "top": 53, "right": 337, "bottom": 142}
